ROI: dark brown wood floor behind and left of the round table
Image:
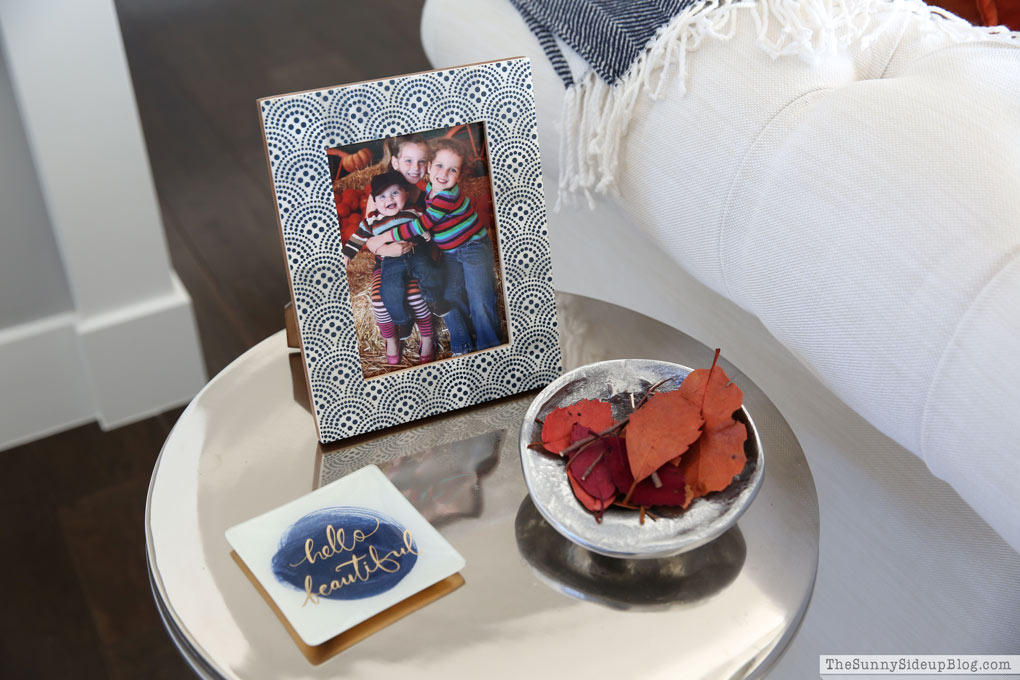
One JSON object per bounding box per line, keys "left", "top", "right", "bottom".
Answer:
{"left": 0, "top": 0, "right": 429, "bottom": 678}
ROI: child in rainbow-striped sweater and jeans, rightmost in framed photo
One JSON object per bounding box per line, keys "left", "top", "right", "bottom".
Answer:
{"left": 373, "top": 138, "right": 505, "bottom": 353}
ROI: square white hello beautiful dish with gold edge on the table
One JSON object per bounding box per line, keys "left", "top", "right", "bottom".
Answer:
{"left": 226, "top": 465, "right": 464, "bottom": 652}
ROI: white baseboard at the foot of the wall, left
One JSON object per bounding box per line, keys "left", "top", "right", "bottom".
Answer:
{"left": 0, "top": 275, "right": 206, "bottom": 450}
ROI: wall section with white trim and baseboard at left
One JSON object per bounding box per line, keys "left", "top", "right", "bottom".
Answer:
{"left": 0, "top": 0, "right": 205, "bottom": 449}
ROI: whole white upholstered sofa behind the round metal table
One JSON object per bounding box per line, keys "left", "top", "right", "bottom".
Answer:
{"left": 422, "top": 0, "right": 1020, "bottom": 678}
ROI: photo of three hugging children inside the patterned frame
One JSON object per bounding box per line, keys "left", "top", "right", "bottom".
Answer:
{"left": 326, "top": 122, "right": 509, "bottom": 378}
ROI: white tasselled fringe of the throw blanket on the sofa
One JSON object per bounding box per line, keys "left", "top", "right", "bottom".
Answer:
{"left": 559, "top": 0, "right": 1020, "bottom": 203}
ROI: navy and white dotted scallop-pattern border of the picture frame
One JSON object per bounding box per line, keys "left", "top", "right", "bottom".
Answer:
{"left": 258, "top": 58, "right": 562, "bottom": 443}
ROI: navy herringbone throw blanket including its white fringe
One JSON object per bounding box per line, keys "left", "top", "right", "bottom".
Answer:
{"left": 510, "top": 0, "right": 1018, "bottom": 198}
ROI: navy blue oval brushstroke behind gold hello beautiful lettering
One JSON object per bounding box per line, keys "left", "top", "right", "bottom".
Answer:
{"left": 272, "top": 507, "right": 418, "bottom": 599}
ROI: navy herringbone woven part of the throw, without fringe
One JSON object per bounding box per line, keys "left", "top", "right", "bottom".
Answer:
{"left": 510, "top": 0, "right": 695, "bottom": 87}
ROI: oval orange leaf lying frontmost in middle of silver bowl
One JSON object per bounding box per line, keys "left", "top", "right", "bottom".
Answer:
{"left": 627, "top": 391, "right": 703, "bottom": 483}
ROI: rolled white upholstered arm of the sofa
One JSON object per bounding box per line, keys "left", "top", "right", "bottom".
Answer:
{"left": 619, "top": 15, "right": 1020, "bottom": 550}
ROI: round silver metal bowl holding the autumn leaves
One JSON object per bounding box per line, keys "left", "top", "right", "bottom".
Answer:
{"left": 520, "top": 359, "right": 765, "bottom": 560}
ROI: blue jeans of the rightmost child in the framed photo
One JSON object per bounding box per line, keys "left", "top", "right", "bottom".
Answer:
{"left": 443, "top": 237, "right": 505, "bottom": 350}
